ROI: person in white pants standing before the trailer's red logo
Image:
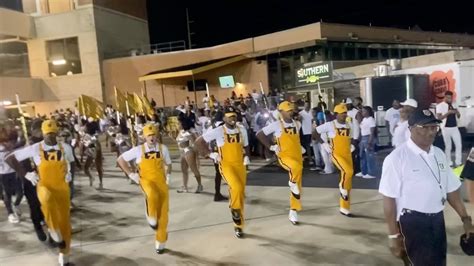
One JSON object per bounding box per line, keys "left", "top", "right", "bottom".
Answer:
{"left": 436, "top": 91, "right": 462, "bottom": 168}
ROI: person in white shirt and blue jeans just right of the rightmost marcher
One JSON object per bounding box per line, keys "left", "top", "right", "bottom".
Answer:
{"left": 356, "top": 106, "right": 376, "bottom": 179}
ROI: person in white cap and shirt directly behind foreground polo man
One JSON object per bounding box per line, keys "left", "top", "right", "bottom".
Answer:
{"left": 392, "top": 99, "right": 418, "bottom": 147}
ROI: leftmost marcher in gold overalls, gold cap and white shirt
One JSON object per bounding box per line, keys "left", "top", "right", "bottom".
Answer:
{"left": 7, "top": 120, "right": 74, "bottom": 265}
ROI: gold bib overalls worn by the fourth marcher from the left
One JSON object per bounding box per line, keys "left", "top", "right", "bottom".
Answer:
{"left": 276, "top": 120, "right": 303, "bottom": 211}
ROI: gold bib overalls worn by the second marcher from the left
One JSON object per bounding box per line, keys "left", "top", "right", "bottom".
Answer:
{"left": 138, "top": 144, "right": 169, "bottom": 243}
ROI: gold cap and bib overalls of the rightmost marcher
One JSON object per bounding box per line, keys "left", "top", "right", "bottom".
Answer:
{"left": 330, "top": 106, "right": 354, "bottom": 211}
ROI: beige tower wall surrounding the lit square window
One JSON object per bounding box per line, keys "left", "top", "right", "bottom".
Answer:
{"left": 28, "top": 6, "right": 102, "bottom": 113}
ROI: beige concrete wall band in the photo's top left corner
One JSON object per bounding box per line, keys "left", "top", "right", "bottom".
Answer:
{"left": 0, "top": 8, "right": 35, "bottom": 38}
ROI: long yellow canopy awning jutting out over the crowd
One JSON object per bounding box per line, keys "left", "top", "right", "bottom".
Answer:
{"left": 138, "top": 55, "right": 247, "bottom": 81}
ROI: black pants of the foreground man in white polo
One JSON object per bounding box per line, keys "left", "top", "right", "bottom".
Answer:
{"left": 399, "top": 211, "right": 447, "bottom": 266}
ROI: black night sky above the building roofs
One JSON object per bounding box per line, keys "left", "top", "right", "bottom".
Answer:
{"left": 148, "top": 0, "right": 474, "bottom": 47}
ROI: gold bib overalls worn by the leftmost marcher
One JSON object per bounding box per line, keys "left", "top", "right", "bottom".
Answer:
{"left": 36, "top": 131, "right": 71, "bottom": 255}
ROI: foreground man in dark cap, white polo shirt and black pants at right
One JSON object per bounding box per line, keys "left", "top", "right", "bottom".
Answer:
{"left": 379, "top": 110, "right": 474, "bottom": 265}
